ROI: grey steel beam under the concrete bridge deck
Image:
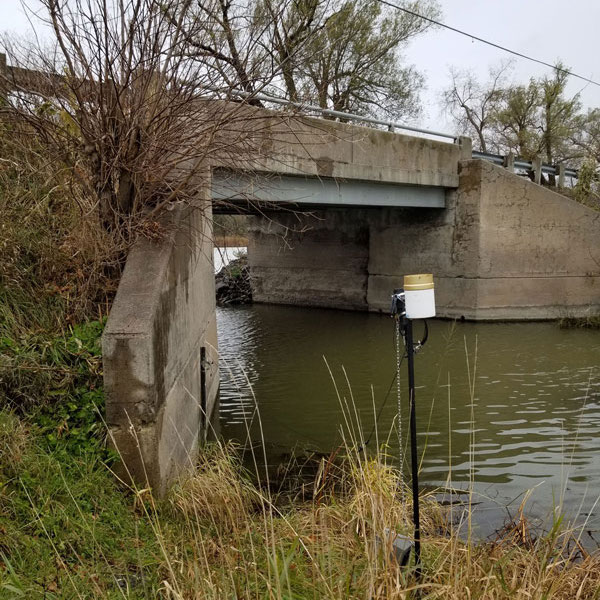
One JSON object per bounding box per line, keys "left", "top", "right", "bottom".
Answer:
{"left": 212, "top": 169, "right": 446, "bottom": 212}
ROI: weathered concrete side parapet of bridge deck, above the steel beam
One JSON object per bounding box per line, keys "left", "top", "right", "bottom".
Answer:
{"left": 212, "top": 109, "right": 461, "bottom": 188}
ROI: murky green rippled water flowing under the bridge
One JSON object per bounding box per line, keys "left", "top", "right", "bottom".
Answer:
{"left": 217, "top": 305, "right": 600, "bottom": 538}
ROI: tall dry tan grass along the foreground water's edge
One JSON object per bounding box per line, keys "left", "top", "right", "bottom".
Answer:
{"left": 151, "top": 438, "right": 600, "bottom": 600}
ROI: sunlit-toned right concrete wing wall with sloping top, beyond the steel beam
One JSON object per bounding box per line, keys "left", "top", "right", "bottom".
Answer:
{"left": 450, "top": 161, "right": 600, "bottom": 319}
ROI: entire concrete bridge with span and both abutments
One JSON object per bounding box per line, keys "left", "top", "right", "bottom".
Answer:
{"left": 103, "top": 110, "right": 600, "bottom": 492}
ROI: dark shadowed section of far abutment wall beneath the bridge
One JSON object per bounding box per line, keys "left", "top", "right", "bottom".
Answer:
{"left": 248, "top": 209, "right": 369, "bottom": 310}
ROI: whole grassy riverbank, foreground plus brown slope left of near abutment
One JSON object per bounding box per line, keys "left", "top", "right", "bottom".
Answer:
{"left": 0, "top": 180, "right": 600, "bottom": 600}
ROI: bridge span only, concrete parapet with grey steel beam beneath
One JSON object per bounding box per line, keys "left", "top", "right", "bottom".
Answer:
{"left": 212, "top": 119, "right": 460, "bottom": 212}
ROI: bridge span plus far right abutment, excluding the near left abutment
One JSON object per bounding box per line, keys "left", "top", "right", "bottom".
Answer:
{"left": 212, "top": 119, "right": 600, "bottom": 320}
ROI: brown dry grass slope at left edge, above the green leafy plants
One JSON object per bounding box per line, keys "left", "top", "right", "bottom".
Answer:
{"left": 0, "top": 119, "right": 123, "bottom": 338}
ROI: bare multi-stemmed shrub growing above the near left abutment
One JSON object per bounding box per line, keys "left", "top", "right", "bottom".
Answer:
{"left": 0, "top": 0, "right": 276, "bottom": 241}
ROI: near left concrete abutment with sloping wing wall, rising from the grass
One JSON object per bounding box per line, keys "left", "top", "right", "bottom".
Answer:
{"left": 103, "top": 198, "right": 219, "bottom": 494}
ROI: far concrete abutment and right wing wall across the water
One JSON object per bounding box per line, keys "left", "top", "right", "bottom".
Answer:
{"left": 249, "top": 160, "right": 600, "bottom": 320}
